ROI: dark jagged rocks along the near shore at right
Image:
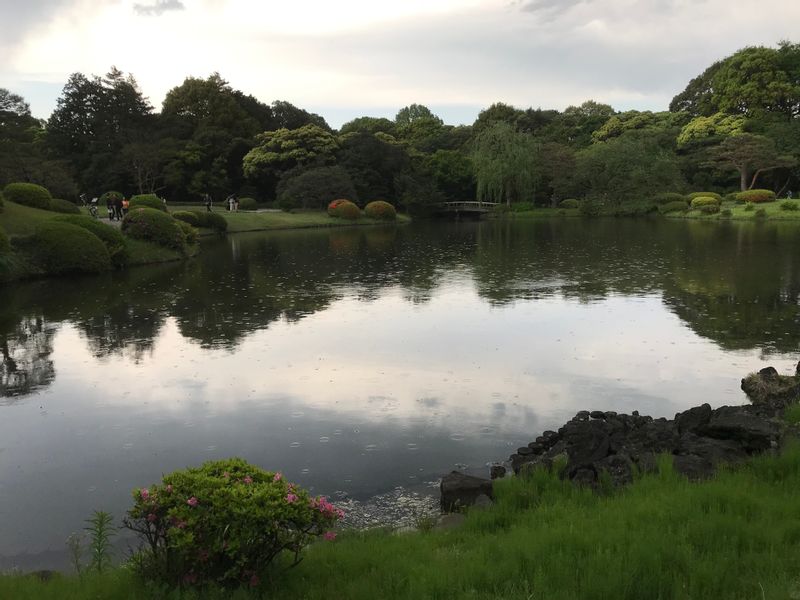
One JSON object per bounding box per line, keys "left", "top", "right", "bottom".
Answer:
{"left": 440, "top": 363, "right": 800, "bottom": 512}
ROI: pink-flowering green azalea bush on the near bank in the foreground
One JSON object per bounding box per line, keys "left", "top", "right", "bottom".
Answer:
{"left": 125, "top": 458, "right": 344, "bottom": 586}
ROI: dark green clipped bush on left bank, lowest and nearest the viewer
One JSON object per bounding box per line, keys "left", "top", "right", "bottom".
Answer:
{"left": 21, "top": 220, "right": 111, "bottom": 275}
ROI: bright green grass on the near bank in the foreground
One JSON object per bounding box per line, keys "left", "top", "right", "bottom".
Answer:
{"left": 6, "top": 443, "right": 800, "bottom": 600}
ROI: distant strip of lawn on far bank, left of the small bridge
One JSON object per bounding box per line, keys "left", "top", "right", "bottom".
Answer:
{"left": 170, "top": 205, "right": 411, "bottom": 233}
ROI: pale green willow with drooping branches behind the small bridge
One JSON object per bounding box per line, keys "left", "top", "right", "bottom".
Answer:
{"left": 472, "top": 122, "right": 540, "bottom": 205}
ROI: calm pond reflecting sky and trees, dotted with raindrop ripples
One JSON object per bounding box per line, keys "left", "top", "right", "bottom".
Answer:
{"left": 0, "top": 219, "right": 800, "bottom": 569}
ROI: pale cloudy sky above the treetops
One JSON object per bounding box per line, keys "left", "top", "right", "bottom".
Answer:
{"left": 0, "top": 0, "right": 800, "bottom": 127}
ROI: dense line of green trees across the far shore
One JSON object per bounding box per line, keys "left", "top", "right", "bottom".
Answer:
{"left": 0, "top": 41, "right": 800, "bottom": 212}
